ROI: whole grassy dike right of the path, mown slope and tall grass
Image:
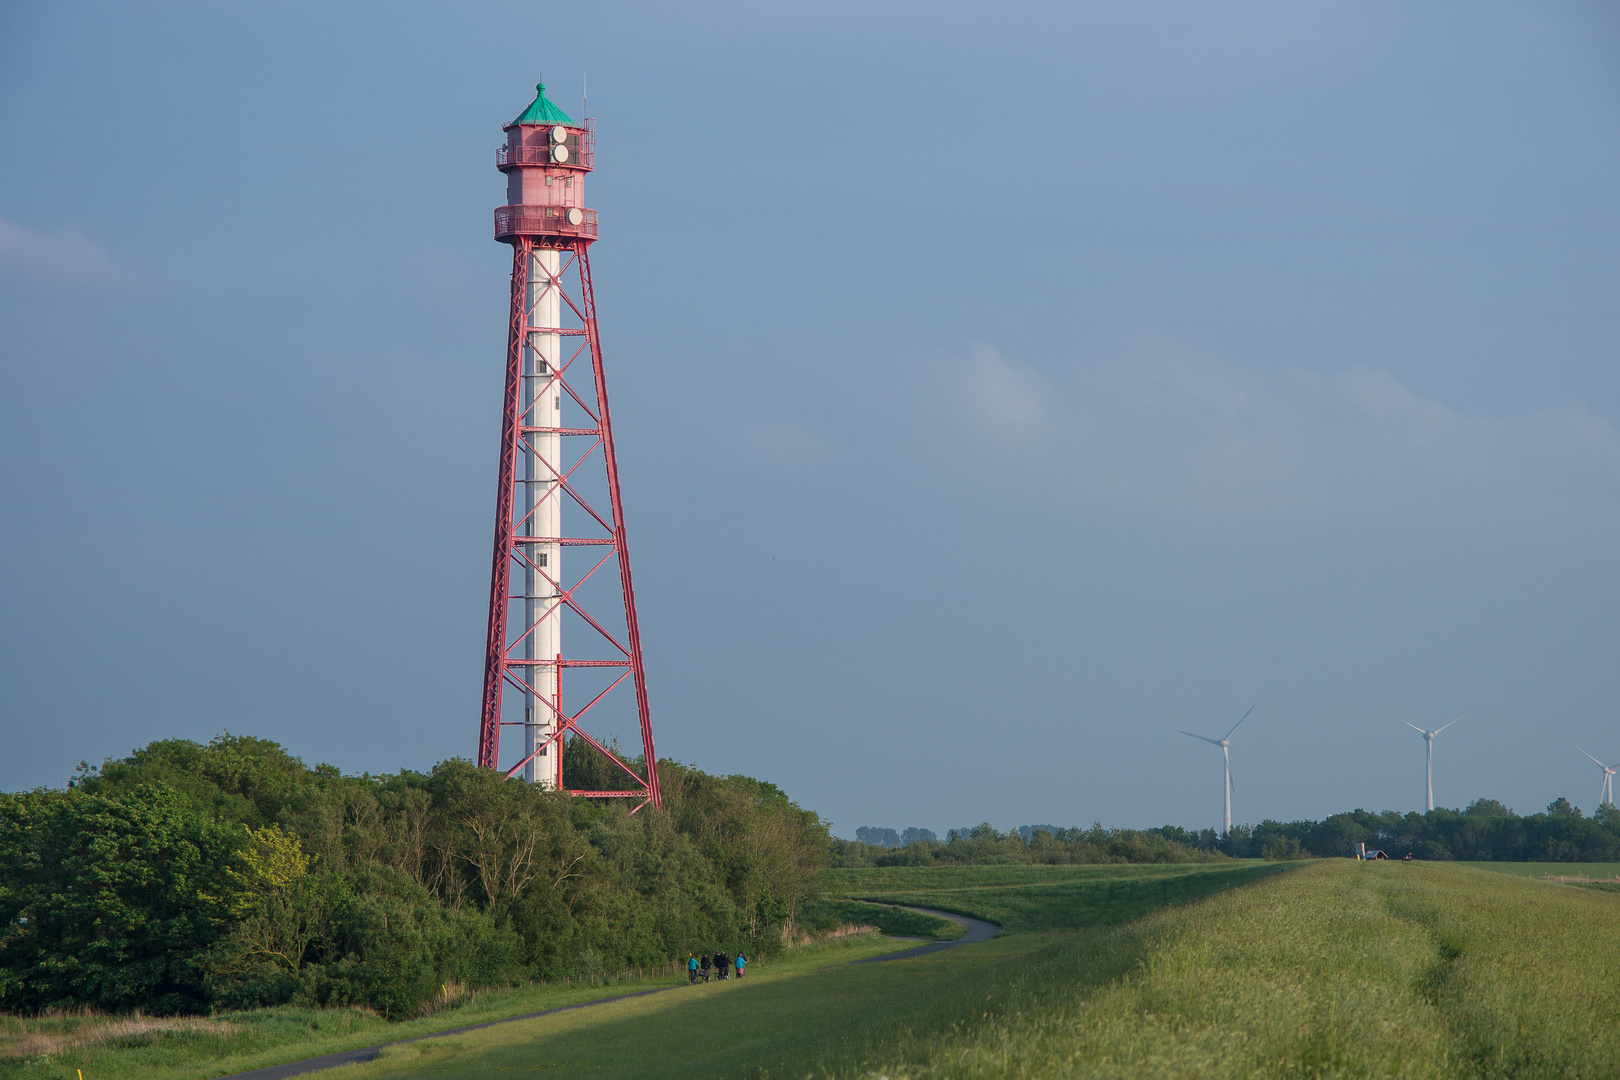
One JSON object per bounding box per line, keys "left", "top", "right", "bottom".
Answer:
{"left": 298, "top": 860, "right": 1620, "bottom": 1080}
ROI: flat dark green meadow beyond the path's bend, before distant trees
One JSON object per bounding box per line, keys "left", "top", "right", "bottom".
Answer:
{"left": 826, "top": 860, "right": 1291, "bottom": 931}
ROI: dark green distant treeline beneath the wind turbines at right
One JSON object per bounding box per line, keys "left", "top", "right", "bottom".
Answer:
{"left": 1160, "top": 798, "right": 1620, "bottom": 863}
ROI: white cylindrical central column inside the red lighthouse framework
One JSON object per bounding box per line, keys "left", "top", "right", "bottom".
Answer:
{"left": 518, "top": 248, "right": 562, "bottom": 787}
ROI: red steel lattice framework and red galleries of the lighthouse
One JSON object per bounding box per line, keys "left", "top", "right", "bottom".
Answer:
{"left": 478, "top": 96, "right": 663, "bottom": 813}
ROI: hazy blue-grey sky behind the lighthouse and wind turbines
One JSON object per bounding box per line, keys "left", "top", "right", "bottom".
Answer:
{"left": 0, "top": 3, "right": 1620, "bottom": 836}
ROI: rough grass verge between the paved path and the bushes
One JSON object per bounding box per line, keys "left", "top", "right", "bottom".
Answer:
{"left": 0, "top": 933, "right": 906, "bottom": 1080}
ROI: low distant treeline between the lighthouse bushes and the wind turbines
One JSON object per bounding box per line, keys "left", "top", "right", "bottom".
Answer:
{"left": 831, "top": 823, "right": 1226, "bottom": 868}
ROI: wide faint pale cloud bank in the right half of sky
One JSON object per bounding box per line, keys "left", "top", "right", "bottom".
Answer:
{"left": 925, "top": 334, "right": 1620, "bottom": 526}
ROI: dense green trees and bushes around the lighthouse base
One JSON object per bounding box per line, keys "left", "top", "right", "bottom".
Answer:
{"left": 0, "top": 735, "right": 829, "bottom": 1018}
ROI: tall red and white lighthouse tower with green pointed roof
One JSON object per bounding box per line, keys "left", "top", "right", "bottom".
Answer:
{"left": 478, "top": 84, "right": 663, "bottom": 810}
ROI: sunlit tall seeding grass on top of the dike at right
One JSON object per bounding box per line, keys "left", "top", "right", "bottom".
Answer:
{"left": 833, "top": 860, "right": 1620, "bottom": 1080}
